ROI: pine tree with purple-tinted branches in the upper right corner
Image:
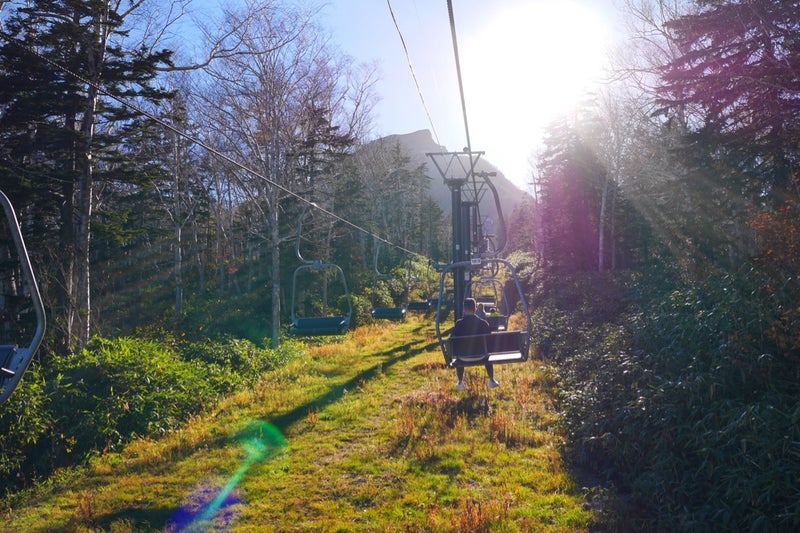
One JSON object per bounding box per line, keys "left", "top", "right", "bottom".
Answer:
{"left": 660, "top": 0, "right": 800, "bottom": 197}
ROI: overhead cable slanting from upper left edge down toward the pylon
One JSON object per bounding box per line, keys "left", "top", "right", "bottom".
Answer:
{"left": 0, "top": 31, "right": 424, "bottom": 261}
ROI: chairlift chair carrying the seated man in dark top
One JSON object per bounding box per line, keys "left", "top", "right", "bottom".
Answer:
{"left": 436, "top": 257, "right": 533, "bottom": 368}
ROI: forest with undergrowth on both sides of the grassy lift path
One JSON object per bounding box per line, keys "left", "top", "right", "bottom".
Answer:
{"left": 0, "top": 0, "right": 800, "bottom": 531}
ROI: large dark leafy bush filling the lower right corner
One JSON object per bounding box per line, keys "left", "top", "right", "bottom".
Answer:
{"left": 562, "top": 269, "right": 800, "bottom": 531}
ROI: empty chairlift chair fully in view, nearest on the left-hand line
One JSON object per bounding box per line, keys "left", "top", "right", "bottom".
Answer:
{"left": 289, "top": 204, "right": 353, "bottom": 337}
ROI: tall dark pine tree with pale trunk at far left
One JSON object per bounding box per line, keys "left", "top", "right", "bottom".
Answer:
{"left": 0, "top": 0, "right": 171, "bottom": 350}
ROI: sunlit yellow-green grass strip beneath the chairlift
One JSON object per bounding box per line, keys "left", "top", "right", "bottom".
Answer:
{"left": 2, "top": 317, "right": 592, "bottom": 532}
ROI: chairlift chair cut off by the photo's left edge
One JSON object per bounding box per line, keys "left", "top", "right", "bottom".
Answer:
{"left": 0, "top": 191, "right": 45, "bottom": 404}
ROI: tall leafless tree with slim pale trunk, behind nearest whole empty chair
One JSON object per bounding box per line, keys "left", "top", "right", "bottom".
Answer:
{"left": 195, "top": 2, "right": 373, "bottom": 346}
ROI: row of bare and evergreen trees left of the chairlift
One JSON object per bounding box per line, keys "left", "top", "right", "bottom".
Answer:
{"left": 0, "top": 1, "right": 446, "bottom": 358}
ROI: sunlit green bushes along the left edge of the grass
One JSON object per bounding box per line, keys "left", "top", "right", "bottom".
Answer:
{"left": 0, "top": 332, "right": 305, "bottom": 490}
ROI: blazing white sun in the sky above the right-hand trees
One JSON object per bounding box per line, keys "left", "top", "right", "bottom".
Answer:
{"left": 461, "top": 0, "right": 608, "bottom": 179}
